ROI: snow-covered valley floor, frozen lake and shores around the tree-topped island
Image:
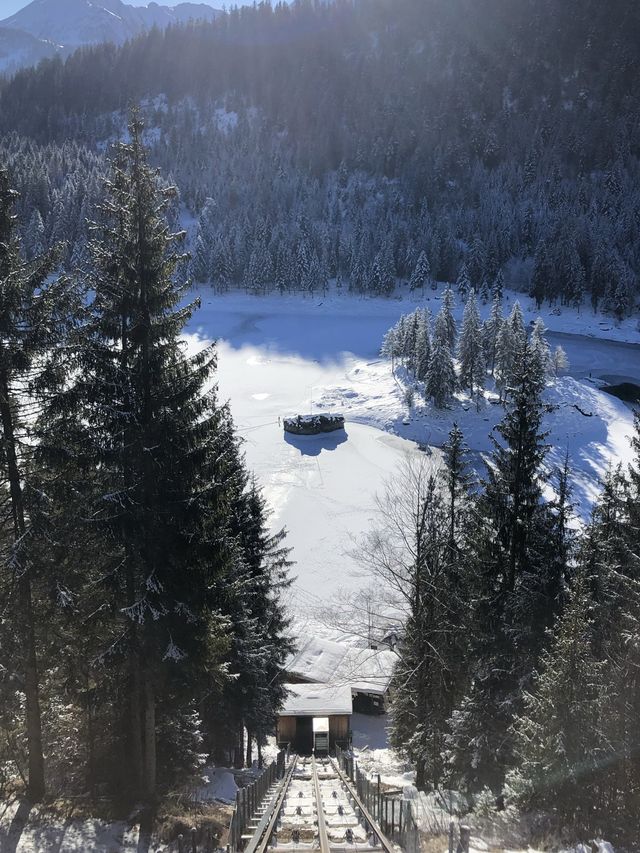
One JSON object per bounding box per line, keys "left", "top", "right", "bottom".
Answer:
{"left": 189, "top": 288, "right": 640, "bottom": 613}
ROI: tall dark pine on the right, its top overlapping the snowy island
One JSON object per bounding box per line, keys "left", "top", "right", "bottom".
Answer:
{"left": 448, "top": 336, "right": 562, "bottom": 793}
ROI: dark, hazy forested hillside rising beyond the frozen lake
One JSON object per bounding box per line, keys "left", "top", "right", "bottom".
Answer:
{"left": 0, "top": 0, "right": 640, "bottom": 316}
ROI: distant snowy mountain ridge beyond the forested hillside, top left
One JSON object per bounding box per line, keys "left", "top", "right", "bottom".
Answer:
{"left": 0, "top": 0, "right": 220, "bottom": 70}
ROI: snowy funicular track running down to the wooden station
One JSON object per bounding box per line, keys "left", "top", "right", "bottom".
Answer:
{"left": 245, "top": 756, "right": 398, "bottom": 853}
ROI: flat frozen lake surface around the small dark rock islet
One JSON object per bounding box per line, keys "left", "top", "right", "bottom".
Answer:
{"left": 185, "top": 300, "right": 419, "bottom": 612}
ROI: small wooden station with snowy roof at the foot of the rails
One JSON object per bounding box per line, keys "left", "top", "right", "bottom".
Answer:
{"left": 277, "top": 684, "right": 352, "bottom": 755}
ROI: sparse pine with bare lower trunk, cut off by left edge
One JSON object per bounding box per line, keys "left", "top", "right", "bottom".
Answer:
{"left": 0, "top": 171, "right": 73, "bottom": 800}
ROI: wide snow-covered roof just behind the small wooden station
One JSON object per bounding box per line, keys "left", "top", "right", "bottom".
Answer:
{"left": 285, "top": 637, "right": 397, "bottom": 694}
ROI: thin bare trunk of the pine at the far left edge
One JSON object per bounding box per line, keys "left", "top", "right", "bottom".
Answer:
{"left": 0, "top": 373, "right": 45, "bottom": 801}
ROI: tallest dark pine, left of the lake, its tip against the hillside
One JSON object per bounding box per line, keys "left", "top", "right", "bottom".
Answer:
{"left": 41, "top": 117, "right": 248, "bottom": 800}
